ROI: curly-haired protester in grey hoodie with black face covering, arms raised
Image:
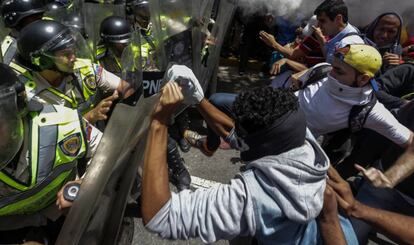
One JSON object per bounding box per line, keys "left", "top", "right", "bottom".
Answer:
{"left": 142, "top": 79, "right": 356, "bottom": 244}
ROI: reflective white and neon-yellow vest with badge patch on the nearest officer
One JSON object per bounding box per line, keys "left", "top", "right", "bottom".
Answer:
{"left": 0, "top": 105, "right": 87, "bottom": 215}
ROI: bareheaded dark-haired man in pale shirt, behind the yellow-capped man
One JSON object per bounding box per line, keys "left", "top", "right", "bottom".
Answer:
{"left": 314, "top": 0, "right": 364, "bottom": 63}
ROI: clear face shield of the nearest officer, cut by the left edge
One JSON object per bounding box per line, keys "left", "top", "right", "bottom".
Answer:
{"left": 0, "top": 87, "right": 24, "bottom": 170}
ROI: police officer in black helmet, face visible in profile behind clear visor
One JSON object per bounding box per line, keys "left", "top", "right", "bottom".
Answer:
{"left": 18, "top": 20, "right": 134, "bottom": 124}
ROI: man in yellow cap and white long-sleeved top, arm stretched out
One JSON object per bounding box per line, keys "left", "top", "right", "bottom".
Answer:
{"left": 297, "top": 44, "right": 414, "bottom": 187}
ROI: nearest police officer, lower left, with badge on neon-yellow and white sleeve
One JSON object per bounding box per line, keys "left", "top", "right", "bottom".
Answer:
{"left": 0, "top": 64, "right": 101, "bottom": 240}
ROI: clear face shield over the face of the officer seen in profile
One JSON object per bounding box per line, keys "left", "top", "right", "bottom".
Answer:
{"left": 38, "top": 28, "right": 93, "bottom": 73}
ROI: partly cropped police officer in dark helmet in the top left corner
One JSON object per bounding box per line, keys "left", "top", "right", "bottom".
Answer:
{"left": 1, "top": 0, "right": 45, "bottom": 64}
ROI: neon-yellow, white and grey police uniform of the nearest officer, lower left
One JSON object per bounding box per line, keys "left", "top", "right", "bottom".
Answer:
{"left": 0, "top": 105, "right": 102, "bottom": 230}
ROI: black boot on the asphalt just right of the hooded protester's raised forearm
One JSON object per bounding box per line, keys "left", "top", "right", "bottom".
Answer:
{"left": 167, "top": 137, "right": 191, "bottom": 191}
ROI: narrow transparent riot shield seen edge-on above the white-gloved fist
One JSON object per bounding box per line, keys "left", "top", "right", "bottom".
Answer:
{"left": 198, "top": 0, "right": 236, "bottom": 91}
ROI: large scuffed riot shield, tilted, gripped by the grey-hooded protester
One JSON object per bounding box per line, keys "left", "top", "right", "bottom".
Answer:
{"left": 56, "top": 95, "right": 159, "bottom": 245}
